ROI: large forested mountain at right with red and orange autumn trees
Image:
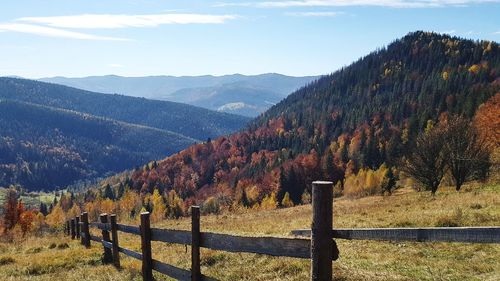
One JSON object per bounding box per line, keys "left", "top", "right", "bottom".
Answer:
{"left": 100, "top": 32, "right": 500, "bottom": 206}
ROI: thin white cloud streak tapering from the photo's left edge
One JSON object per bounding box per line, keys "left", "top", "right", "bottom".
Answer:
{"left": 0, "top": 23, "right": 128, "bottom": 41}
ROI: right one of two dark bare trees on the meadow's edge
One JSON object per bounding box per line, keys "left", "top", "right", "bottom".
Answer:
{"left": 441, "top": 116, "right": 491, "bottom": 191}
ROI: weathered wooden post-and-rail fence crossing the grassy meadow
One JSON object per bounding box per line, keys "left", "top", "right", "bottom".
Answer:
{"left": 65, "top": 181, "right": 500, "bottom": 281}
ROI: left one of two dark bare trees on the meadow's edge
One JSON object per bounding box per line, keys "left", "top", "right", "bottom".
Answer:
{"left": 402, "top": 127, "right": 446, "bottom": 195}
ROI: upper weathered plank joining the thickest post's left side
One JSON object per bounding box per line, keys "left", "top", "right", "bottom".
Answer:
{"left": 201, "top": 232, "right": 311, "bottom": 258}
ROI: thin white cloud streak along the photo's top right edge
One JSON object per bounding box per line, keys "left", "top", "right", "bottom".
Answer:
{"left": 215, "top": 0, "right": 500, "bottom": 8}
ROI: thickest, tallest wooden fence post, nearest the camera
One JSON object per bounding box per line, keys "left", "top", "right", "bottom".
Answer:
{"left": 311, "top": 181, "right": 334, "bottom": 281}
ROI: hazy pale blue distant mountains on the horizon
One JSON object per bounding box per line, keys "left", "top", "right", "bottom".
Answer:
{"left": 40, "top": 73, "right": 318, "bottom": 117}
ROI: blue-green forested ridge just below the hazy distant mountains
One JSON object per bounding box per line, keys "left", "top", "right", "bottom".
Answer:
{"left": 0, "top": 77, "right": 249, "bottom": 140}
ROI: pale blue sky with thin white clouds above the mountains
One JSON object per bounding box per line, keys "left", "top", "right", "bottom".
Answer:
{"left": 0, "top": 0, "right": 500, "bottom": 78}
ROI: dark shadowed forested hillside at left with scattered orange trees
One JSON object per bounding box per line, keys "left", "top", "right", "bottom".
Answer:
{"left": 0, "top": 100, "right": 196, "bottom": 190}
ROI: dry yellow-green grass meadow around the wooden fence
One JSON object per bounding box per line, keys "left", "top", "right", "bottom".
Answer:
{"left": 0, "top": 184, "right": 500, "bottom": 281}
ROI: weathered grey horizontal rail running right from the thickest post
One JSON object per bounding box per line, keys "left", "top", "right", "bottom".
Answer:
{"left": 292, "top": 226, "right": 500, "bottom": 243}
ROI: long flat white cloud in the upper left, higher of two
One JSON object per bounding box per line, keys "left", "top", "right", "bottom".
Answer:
{"left": 17, "top": 14, "right": 237, "bottom": 29}
